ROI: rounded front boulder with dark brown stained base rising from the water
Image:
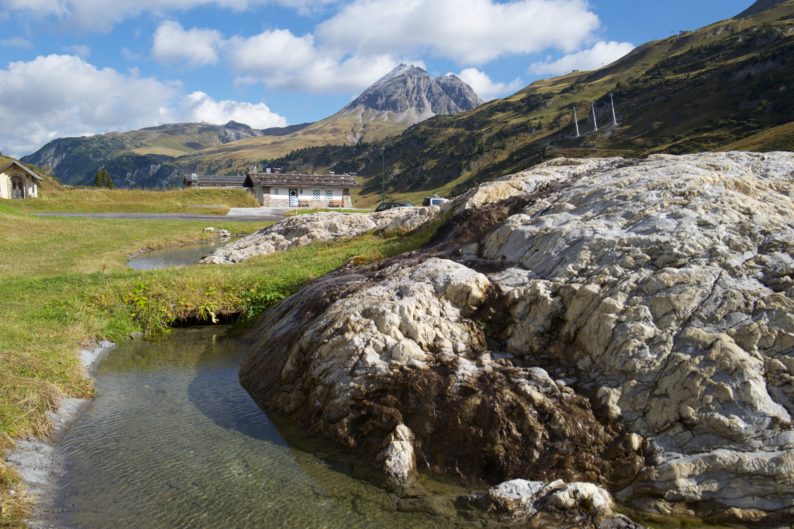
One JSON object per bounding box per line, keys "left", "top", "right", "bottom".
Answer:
{"left": 241, "top": 258, "right": 641, "bottom": 482}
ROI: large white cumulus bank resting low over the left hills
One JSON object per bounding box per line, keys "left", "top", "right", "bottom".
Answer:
{"left": 0, "top": 55, "right": 286, "bottom": 155}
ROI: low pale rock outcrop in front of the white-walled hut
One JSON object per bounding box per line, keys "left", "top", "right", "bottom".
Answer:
{"left": 201, "top": 207, "right": 439, "bottom": 264}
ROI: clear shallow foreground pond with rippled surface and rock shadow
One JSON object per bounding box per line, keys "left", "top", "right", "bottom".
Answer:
{"left": 50, "top": 328, "right": 470, "bottom": 529}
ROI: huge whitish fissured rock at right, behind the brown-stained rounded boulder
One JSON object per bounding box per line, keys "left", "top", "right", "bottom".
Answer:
{"left": 474, "top": 153, "right": 794, "bottom": 510}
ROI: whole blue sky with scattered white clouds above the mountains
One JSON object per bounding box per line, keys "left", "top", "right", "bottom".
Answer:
{"left": 0, "top": 0, "right": 753, "bottom": 156}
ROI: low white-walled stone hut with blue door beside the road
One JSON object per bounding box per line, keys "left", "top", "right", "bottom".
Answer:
{"left": 245, "top": 172, "right": 358, "bottom": 208}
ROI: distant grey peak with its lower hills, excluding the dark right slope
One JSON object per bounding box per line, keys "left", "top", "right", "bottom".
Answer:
{"left": 22, "top": 65, "right": 482, "bottom": 187}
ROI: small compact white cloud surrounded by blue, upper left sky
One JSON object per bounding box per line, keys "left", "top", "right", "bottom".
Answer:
{"left": 152, "top": 21, "right": 222, "bottom": 66}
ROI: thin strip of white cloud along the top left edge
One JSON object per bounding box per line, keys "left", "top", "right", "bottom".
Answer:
{"left": 2, "top": 0, "right": 338, "bottom": 31}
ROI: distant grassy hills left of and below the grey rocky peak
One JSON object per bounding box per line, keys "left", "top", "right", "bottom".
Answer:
{"left": 23, "top": 87, "right": 446, "bottom": 188}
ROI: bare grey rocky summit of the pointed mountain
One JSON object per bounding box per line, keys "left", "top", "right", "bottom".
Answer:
{"left": 347, "top": 64, "right": 482, "bottom": 121}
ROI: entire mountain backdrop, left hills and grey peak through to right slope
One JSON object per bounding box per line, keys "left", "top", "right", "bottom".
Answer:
{"left": 23, "top": 0, "right": 794, "bottom": 194}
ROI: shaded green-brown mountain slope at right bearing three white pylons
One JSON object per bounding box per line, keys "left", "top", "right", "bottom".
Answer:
{"left": 264, "top": 0, "right": 794, "bottom": 203}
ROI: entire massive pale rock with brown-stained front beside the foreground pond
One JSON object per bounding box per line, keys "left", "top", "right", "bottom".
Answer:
{"left": 241, "top": 153, "right": 794, "bottom": 523}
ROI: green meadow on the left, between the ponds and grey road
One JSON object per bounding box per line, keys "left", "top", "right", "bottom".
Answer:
{"left": 0, "top": 205, "right": 440, "bottom": 528}
